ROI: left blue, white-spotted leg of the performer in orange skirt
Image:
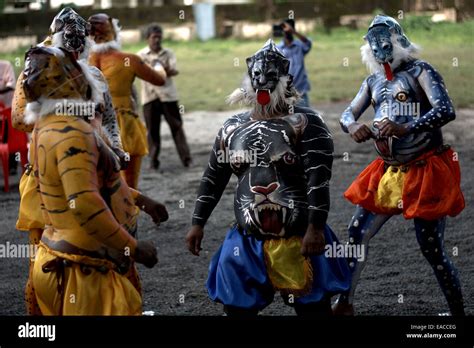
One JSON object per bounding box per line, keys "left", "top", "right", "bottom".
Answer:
{"left": 334, "top": 206, "right": 392, "bottom": 315}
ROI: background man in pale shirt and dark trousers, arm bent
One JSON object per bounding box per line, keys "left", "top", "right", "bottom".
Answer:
{"left": 138, "top": 24, "right": 191, "bottom": 169}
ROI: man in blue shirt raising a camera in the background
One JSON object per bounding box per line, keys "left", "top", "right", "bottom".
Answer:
{"left": 278, "top": 19, "right": 311, "bottom": 107}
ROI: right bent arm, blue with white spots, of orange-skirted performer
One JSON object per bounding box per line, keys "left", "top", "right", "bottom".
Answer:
{"left": 408, "top": 62, "right": 456, "bottom": 133}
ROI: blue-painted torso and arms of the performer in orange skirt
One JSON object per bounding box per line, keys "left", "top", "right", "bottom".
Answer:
{"left": 341, "top": 60, "right": 455, "bottom": 165}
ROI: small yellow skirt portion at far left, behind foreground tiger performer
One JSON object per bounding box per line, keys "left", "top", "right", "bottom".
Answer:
{"left": 16, "top": 172, "right": 44, "bottom": 231}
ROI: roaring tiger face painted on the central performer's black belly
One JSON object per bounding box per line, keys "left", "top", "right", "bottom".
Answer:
{"left": 225, "top": 119, "right": 307, "bottom": 238}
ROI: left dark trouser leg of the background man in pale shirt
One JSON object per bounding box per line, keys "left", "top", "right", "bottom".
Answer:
{"left": 143, "top": 100, "right": 162, "bottom": 169}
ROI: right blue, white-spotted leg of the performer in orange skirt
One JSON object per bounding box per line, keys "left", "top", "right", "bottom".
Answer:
{"left": 415, "top": 218, "right": 464, "bottom": 316}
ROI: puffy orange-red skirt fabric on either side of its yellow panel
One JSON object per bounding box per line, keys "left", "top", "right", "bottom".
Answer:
{"left": 344, "top": 149, "right": 465, "bottom": 220}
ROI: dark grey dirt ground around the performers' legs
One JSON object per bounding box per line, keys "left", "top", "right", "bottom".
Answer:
{"left": 0, "top": 103, "right": 474, "bottom": 315}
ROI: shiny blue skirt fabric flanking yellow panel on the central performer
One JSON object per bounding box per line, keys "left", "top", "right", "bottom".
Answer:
{"left": 206, "top": 225, "right": 351, "bottom": 310}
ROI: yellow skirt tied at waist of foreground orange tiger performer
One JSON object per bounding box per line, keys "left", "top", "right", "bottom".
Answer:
{"left": 33, "top": 244, "right": 142, "bottom": 315}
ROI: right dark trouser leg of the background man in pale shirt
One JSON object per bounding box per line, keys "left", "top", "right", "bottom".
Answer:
{"left": 163, "top": 102, "right": 191, "bottom": 167}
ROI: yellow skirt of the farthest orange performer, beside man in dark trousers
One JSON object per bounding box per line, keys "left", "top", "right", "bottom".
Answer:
{"left": 115, "top": 109, "right": 148, "bottom": 156}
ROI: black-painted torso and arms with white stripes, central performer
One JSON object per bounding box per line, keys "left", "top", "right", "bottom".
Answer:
{"left": 193, "top": 108, "right": 333, "bottom": 238}
